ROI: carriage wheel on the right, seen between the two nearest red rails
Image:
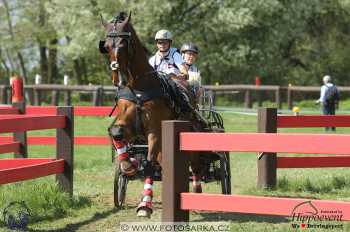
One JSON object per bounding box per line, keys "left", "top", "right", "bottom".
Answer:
{"left": 219, "top": 152, "right": 231, "bottom": 194}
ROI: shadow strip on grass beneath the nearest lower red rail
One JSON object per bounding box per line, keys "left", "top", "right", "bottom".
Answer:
{"left": 191, "top": 213, "right": 289, "bottom": 224}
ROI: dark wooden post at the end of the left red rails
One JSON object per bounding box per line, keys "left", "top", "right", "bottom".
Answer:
{"left": 56, "top": 106, "right": 74, "bottom": 196}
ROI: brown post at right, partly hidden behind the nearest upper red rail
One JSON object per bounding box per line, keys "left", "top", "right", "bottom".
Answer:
{"left": 257, "top": 108, "right": 277, "bottom": 188}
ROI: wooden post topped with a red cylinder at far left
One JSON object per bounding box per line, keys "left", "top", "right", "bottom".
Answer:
{"left": 10, "top": 76, "right": 28, "bottom": 158}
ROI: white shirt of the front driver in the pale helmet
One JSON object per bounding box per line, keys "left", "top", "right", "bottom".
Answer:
{"left": 148, "top": 48, "right": 184, "bottom": 75}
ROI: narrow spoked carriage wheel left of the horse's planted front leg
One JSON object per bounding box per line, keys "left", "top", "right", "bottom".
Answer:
{"left": 114, "top": 163, "right": 128, "bottom": 207}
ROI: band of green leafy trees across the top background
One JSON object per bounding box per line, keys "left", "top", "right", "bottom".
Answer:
{"left": 0, "top": 0, "right": 350, "bottom": 85}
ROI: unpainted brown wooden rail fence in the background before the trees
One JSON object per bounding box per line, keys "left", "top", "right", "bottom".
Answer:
{"left": 0, "top": 84, "right": 350, "bottom": 109}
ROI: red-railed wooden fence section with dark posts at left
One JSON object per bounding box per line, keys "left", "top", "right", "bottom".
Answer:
{"left": 0, "top": 102, "right": 74, "bottom": 196}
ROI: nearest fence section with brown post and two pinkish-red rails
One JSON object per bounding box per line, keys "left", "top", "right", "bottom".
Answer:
{"left": 162, "top": 121, "right": 350, "bottom": 222}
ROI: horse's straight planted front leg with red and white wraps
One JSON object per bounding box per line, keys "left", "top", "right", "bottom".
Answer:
{"left": 136, "top": 133, "right": 160, "bottom": 217}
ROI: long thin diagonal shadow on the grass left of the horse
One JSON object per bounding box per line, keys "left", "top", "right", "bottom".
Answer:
{"left": 27, "top": 208, "right": 119, "bottom": 232}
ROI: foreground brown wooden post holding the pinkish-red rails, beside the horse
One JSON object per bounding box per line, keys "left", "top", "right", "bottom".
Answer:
{"left": 162, "top": 121, "right": 191, "bottom": 222}
